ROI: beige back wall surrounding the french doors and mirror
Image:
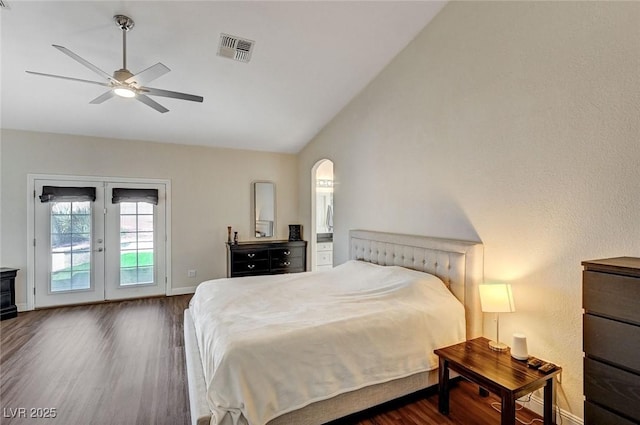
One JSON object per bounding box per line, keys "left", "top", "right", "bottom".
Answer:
{"left": 0, "top": 130, "right": 298, "bottom": 304}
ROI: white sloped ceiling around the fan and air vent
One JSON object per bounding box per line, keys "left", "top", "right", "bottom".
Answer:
{"left": 0, "top": 0, "right": 444, "bottom": 153}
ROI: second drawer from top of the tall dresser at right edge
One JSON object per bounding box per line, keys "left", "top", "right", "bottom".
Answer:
{"left": 583, "top": 314, "right": 640, "bottom": 373}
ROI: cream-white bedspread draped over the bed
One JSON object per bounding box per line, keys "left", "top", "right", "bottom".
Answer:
{"left": 190, "top": 261, "right": 465, "bottom": 425}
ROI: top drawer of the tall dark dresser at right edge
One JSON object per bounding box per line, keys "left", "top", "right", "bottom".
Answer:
{"left": 582, "top": 271, "right": 640, "bottom": 325}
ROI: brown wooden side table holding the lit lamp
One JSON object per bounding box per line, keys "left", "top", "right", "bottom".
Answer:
{"left": 434, "top": 338, "right": 562, "bottom": 425}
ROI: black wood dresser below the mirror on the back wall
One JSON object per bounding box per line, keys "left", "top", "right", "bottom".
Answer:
{"left": 227, "top": 241, "right": 307, "bottom": 277}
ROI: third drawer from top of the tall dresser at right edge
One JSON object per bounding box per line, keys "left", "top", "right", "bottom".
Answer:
{"left": 584, "top": 357, "right": 640, "bottom": 421}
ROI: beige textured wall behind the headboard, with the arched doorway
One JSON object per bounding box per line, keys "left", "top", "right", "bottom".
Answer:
{"left": 299, "top": 2, "right": 640, "bottom": 417}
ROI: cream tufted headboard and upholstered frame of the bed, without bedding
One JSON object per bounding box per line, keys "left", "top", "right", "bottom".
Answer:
{"left": 184, "top": 230, "right": 483, "bottom": 425}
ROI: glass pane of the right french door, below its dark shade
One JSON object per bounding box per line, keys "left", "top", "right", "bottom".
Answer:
{"left": 120, "top": 202, "right": 154, "bottom": 286}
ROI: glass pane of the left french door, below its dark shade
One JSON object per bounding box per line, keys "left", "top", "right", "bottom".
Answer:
{"left": 49, "top": 201, "right": 91, "bottom": 292}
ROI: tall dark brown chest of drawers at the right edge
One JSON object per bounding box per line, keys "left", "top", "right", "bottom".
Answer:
{"left": 582, "top": 257, "right": 640, "bottom": 425}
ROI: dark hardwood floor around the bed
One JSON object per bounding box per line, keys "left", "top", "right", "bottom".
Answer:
{"left": 0, "top": 295, "right": 539, "bottom": 425}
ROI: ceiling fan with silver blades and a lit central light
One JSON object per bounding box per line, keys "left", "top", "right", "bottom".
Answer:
{"left": 27, "top": 15, "right": 204, "bottom": 113}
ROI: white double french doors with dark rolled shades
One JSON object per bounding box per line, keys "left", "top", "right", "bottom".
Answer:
{"left": 33, "top": 179, "right": 166, "bottom": 308}
